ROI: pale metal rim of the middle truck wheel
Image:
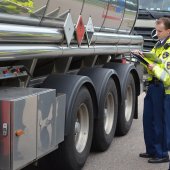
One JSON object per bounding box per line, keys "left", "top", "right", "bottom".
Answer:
{"left": 104, "top": 93, "right": 115, "bottom": 134}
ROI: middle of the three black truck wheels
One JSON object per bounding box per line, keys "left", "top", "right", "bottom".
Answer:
{"left": 93, "top": 78, "right": 118, "bottom": 151}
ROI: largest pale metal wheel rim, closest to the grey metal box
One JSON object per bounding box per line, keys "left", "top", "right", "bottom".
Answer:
{"left": 75, "top": 103, "right": 89, "bottom": 153}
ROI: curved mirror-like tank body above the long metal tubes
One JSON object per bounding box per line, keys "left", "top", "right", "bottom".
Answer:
{"left": 0, "top": 0, "right": 138, "bottom": 34}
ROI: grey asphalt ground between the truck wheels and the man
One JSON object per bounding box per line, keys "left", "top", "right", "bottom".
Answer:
{"left": 83, "top": 93, "right": 169, "bottom": 170}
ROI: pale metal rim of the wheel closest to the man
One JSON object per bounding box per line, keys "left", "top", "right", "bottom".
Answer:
{"left": 125, "top": 86, "right": 133, "bottom": 121}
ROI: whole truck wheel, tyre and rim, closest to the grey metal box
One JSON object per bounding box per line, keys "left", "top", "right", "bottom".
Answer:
{"left": 59, "top": 87, "right": 93, "bottom": 170}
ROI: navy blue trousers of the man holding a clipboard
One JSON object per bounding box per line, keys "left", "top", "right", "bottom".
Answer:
{"left": 143, "top": 83, "right": 168, "bottom": 158}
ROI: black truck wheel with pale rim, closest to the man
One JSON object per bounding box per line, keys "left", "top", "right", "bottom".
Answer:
{"left": 116, "top": 74, "right": 136, "bottom": 136}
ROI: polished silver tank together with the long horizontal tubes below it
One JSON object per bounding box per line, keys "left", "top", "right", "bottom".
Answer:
{"left": 0, "top": 0, "right": 143, "bottom": 61}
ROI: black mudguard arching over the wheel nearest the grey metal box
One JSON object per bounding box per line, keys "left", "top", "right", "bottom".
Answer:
{"left": 41, "top": 74, "right": 98, "bottom": 136}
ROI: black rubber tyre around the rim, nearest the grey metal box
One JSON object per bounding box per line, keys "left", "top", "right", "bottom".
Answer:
{"left": 57, "top": 87, "right": 93, "bottom": 170}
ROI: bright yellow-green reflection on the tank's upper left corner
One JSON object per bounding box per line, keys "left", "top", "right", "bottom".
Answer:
{"left": 0, "top": 0, "right": 33, "bottom": 14}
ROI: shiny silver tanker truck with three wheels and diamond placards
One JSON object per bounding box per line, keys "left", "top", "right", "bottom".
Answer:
{"left": 0, "top": 0, "right": 143, "bottom": 170}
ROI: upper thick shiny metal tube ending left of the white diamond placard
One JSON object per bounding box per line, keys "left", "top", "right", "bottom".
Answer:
{"left": 0, "top": 24, "right": 64, "bottom": 43}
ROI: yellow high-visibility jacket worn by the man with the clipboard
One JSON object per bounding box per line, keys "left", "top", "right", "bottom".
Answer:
{"left": 145, "top": 37, "right": 170, "bottom": 94}
